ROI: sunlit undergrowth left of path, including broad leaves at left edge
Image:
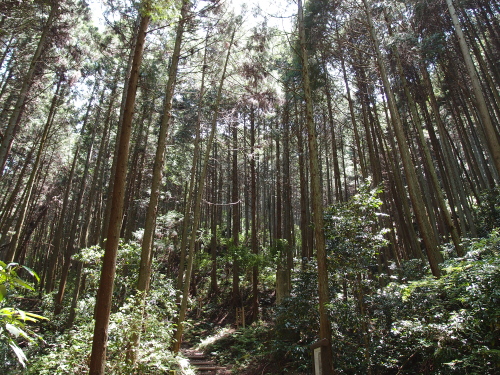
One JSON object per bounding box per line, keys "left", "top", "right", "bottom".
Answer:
{"left": 0, "top": 244, "right": 189, "bottom": 374}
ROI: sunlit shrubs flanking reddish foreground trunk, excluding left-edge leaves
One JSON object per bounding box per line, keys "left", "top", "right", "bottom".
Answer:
{"left": 23, "top": 243, "right": 186, "bottom": 375}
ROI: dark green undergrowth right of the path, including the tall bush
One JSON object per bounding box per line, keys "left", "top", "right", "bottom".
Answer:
{"left": 197, "top": 191, "right": 500, "bottom": 374}
